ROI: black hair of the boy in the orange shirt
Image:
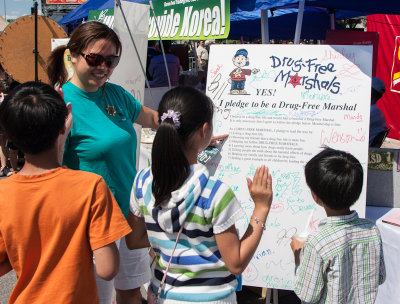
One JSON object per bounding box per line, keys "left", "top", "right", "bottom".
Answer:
{"left": 0, "top": 81, "right": 68, "bottom": 154}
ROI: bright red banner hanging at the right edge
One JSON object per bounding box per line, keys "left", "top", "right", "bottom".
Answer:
{"left": 367, "top": 14, "right": 400, "bottom": 139}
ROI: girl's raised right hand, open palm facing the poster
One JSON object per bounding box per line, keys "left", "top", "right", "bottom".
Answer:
{"left": 247, "top": 166, "right": 272, "bottom": 210}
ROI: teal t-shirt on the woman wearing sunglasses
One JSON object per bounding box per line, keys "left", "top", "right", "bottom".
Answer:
{"left": 62, "top": 82, "right": 141, "bottom": 217}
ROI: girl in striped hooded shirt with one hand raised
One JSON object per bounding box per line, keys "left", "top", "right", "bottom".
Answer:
{"left": 126, "top": 87, "right": 272, "bottom": 304}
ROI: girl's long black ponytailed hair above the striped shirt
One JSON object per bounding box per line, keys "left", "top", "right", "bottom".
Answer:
{"left": 151, "top": 87, "right": 213, "bottom": 206}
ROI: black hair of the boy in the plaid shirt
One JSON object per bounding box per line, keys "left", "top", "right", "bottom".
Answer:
{"left": 305, "top": 148, "right": 363, "bottom": 210}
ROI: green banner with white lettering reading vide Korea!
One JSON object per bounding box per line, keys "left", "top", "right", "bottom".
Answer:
{"left": 149, "top": 0, "right": 230, "bottom": 40}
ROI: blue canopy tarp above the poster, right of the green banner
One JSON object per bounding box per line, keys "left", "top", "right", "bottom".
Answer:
{"left": 229, "top": 0, "right": 384, "bottom": 40}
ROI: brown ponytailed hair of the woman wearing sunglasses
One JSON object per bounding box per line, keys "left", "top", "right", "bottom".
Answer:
{"left": 46, "top": 21, "right": 122, "bottom": 87}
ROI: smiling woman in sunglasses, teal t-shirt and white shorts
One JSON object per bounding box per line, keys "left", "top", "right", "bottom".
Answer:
{"left": 47, "top": 22, "right": 158, "bottom": 304}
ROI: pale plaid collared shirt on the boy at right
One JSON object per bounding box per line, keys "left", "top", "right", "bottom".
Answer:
{"left": 294, "top": 211, "right": 386, "bottom": 304}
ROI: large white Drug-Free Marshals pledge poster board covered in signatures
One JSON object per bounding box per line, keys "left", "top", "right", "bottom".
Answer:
{"left": 206, "top": 45, "right": 372, "bottom": 289}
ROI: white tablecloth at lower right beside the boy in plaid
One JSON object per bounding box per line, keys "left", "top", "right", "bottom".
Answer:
{"left": 366, "top": 206, "right": 400, "bottom": 304}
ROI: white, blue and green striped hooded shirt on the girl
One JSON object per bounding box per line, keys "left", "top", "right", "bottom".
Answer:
{"left": 131, "top": 164, "right": 245, "bottom": 303}
